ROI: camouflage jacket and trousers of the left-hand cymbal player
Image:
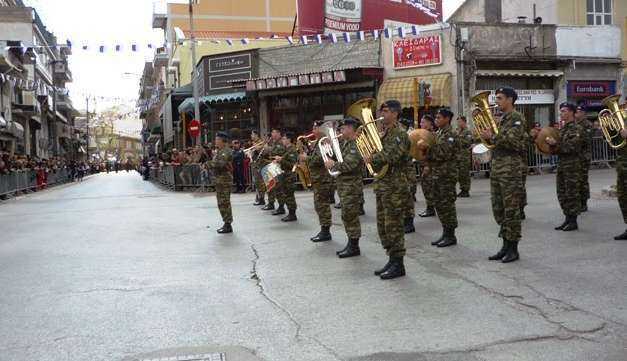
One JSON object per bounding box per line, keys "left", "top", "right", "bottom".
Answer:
{"left": 427, "top": 125, "right": 459, "bottom": 229}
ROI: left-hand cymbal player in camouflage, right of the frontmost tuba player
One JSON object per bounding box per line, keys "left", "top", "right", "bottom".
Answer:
{"left": 418, "top": 109, "right": 459, "bottom": 247}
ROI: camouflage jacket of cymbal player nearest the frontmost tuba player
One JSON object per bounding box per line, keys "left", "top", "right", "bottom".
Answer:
{"left": 427, "top": 125, "right": 459, "bottom": 177}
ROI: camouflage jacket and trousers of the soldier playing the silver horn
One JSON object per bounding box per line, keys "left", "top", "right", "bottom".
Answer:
{"left": 332, "top": 140, "right": 364, "bottom": 239}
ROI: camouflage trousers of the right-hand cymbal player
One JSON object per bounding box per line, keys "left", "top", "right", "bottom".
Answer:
{"left": 556, "top": 157, "right": 582, "bottom": 216}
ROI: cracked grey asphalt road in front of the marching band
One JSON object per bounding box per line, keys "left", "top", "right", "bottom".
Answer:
{"left": 0, "top": 170, "right": 627, "bottom": 361}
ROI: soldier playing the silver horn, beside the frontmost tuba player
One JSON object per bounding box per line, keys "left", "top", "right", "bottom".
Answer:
{"left": 325, "top": 118, "right": 364, "bottom": 258}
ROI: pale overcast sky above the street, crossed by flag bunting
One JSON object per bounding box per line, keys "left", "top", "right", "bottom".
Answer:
{"left": 25, "top": 0, "right": 463, "bottom": 109}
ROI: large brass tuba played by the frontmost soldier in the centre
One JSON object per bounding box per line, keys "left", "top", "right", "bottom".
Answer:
{"left": 346, "top": 98, "right": 388, "bottom": 179}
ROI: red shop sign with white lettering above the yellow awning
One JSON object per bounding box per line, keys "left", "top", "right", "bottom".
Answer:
{"left": 393, "top": 35, "right": 442, "bottom": 69}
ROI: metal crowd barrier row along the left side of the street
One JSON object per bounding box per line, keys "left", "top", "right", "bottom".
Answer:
{"left": 0, "top": 168, "right": 72, "bottom": 199}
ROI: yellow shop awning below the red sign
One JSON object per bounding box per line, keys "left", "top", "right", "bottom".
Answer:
{"left": 377, "top": 74, "right": 451, "bottom": 108}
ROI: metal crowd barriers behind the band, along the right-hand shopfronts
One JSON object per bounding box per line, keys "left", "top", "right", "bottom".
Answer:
{"left": 149, "top": 137, "right": 616, "bottom": 191}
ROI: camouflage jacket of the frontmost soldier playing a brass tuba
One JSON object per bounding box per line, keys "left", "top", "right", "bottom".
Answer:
{"left": 372, "top": 126, "right": 410, "bottom": 187}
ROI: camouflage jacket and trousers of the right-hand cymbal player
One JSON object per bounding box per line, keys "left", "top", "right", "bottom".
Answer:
{"left": 556, "top": 121, "right": 584, "bottom": 216}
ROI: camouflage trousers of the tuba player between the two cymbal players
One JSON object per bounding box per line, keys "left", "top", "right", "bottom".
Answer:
{"left": 490, "top": 158, "right": 526, "bottom": 242}
